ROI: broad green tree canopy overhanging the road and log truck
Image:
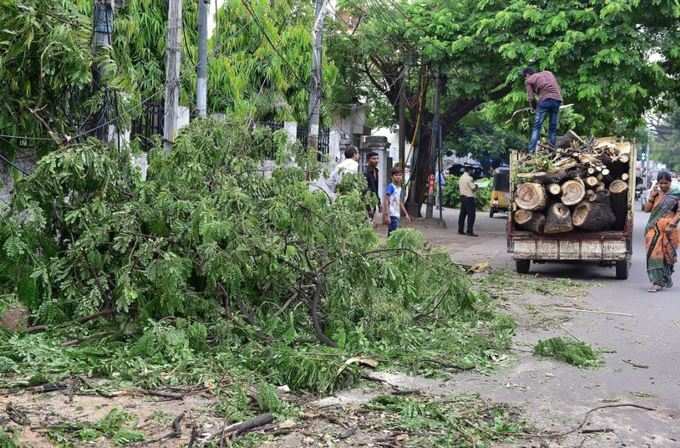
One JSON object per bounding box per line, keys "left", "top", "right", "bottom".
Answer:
{"left": 331, "top": 0, "right": 680, "bottom": 214}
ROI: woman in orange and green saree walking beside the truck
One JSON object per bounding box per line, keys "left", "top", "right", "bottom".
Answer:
{"left": 644, "top": 171, "right": 680, "bottom": 292}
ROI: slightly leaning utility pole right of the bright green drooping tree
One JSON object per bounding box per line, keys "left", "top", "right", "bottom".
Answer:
{"left": 307, "top": 0, "right": 328, "bottom": 152}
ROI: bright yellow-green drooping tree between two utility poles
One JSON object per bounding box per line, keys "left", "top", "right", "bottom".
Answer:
{"left": 208, "top": 0, "right": 337, "bottom": 123}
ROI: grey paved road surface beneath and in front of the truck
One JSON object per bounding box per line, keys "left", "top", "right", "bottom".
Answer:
{"left": 412, "top": 210, "right": 680, "bottom": 448}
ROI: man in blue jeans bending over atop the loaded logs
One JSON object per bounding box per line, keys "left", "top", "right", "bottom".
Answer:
{"left": 522, "top": 67, "right": 562, "bottom": 152}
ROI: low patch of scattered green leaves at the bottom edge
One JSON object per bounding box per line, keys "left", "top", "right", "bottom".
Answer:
{"left": 365, "top": 395, "right": 524, "bottom": 448}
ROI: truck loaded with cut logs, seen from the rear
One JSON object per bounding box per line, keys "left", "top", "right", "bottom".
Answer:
{"left": 507, "top": 132, "right": 635, "bottom": 279}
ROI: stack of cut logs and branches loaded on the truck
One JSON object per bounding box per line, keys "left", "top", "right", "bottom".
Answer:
{"left": 513, "top": 133, "right": 635, "bottom": 234}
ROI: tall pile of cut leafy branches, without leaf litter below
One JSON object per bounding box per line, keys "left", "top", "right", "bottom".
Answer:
{"left": 0, "top": 120, "right": 486, "bottom": 354}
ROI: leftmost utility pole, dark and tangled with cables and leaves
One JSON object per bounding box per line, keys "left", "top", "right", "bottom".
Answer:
{"left": 92, "top": 0, "right": 113, "bottom": 141}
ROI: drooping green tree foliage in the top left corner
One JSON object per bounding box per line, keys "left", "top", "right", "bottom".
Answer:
{"left": 0, "top": 0, "right": 94, "bottom": 149}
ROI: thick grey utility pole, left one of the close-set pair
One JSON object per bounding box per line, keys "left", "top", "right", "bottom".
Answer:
{"left": 163, "top": 0, "right": 182, "bottom": 152}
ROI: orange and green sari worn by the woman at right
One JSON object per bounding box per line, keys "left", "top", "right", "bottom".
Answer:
{"left": 645, "top": 194, "right": 680, "bottom": 288}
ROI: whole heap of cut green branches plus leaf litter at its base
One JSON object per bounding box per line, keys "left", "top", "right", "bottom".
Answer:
{"left": 0, "top": 121, "right": 514, "bottom": 392}
